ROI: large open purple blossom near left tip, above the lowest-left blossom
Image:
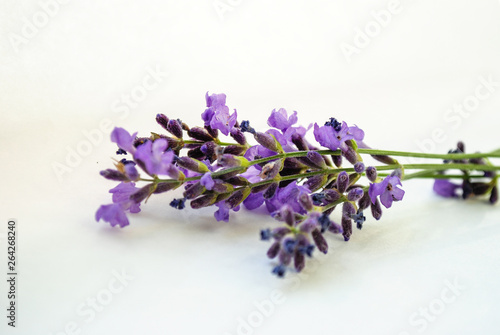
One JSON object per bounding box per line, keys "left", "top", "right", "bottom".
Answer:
{"left": 134, "top": 138, "right": 178, "bottom": 178}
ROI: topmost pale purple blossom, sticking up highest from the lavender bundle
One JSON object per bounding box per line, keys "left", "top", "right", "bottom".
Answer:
{"left": 201, "top": 92, "right": 238, "bottom": 136}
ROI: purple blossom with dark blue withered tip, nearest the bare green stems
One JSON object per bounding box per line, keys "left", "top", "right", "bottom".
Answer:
{"left": 314, "top": 122, "right": 365, "bottom": 151}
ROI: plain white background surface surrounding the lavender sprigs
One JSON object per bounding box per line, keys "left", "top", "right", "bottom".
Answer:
{"left": 0, "top": 0, "right": 500, "bottom": 335}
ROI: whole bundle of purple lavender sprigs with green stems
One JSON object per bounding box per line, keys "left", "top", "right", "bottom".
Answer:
{"left": 95, "top": 93, "right": 500, "bottom": 277}
